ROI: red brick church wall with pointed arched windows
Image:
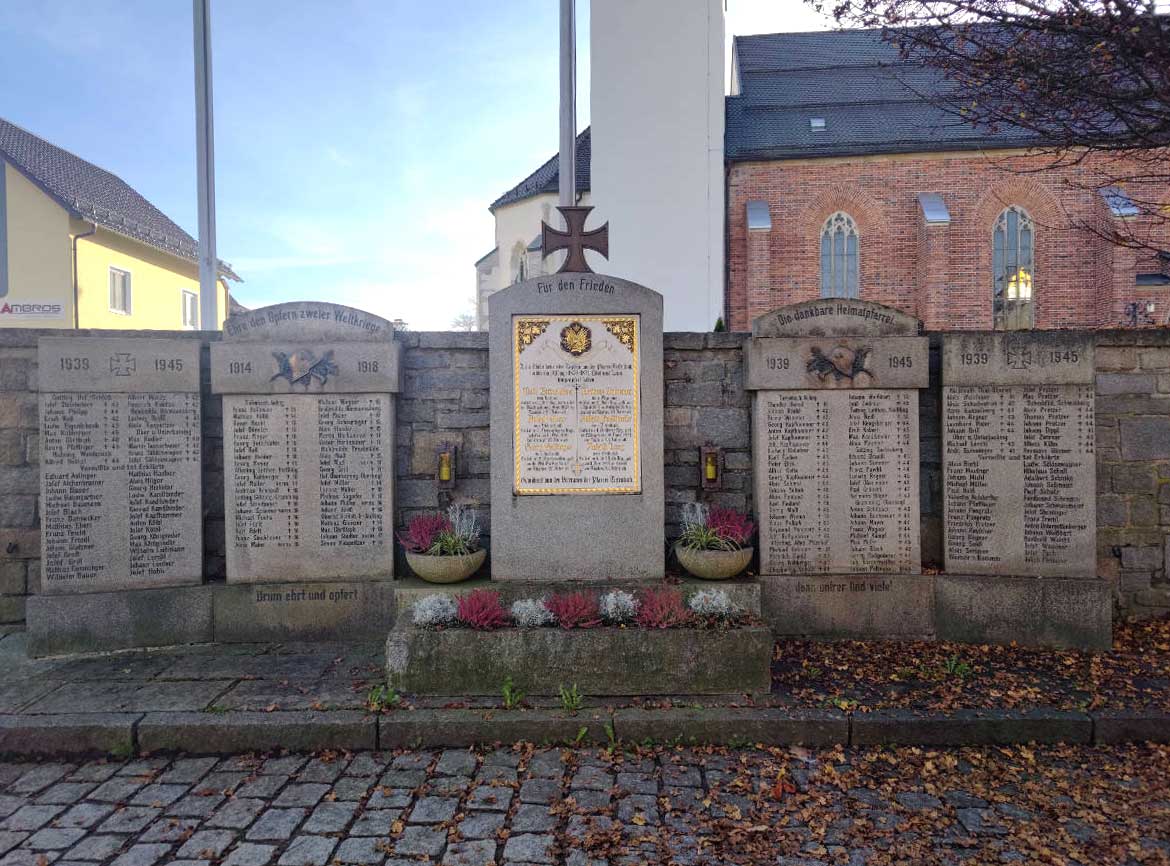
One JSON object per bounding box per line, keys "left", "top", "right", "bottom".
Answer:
{"left": 727, "top": 151, "right": 1170, "bottom": 330}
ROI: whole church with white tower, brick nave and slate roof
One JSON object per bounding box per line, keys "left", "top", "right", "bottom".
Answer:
{"left": 476, "top": 0, "right": 1170, "bottom": 331}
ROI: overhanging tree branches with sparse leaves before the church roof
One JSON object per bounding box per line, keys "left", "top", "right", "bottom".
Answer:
{"left": 808, "top": 0, "right": 1170, "bottom": 250}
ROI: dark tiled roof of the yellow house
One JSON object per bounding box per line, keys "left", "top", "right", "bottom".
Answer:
{"left": 0, "top": 118, "right": 240, "bottom": 281}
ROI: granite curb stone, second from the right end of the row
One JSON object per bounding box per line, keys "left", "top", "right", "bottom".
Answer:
{"left": 849, "top": 708, "right": 1093, "bottom": 745}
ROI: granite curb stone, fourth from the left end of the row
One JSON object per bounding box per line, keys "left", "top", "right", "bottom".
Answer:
{"left": 613, "top": 707, "right": 849, "bottom": 745}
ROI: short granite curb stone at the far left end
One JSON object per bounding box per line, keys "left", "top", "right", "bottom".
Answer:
{"left": 0, "top": 713, "right": 142, "bottom": 757}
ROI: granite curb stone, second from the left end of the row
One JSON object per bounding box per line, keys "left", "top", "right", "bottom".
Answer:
{"left": 138, "top": 710, "right": 378, "bottom": 755}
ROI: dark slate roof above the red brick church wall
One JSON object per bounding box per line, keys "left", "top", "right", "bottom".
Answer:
{"left": 725, "top": 30, "right": 1035, "bottom": 160}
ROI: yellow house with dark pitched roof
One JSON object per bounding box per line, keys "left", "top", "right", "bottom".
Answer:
{"left": 0, "top": 119, "right": 240, "bottom": 330}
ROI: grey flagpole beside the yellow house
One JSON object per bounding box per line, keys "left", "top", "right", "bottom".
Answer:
{"left": 193, "top": 0, "right": 218, "bottom": 331}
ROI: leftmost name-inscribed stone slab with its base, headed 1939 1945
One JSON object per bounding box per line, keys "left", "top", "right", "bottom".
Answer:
{"left": 27, "top": 337, "right": 212, "bottom": 655}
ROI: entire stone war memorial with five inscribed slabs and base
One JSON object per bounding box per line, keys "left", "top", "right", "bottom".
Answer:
{"left": 16, "top": 209, "right": 1113, "bottom": 664}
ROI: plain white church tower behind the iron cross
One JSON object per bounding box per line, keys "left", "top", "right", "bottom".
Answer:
{"left": 590, "top": 0, "right": 725, "bottom": 331}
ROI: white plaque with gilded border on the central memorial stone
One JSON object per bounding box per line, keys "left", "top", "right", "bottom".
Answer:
{"left": 511, "top": 315, "right": 641, "bottom": 496}
